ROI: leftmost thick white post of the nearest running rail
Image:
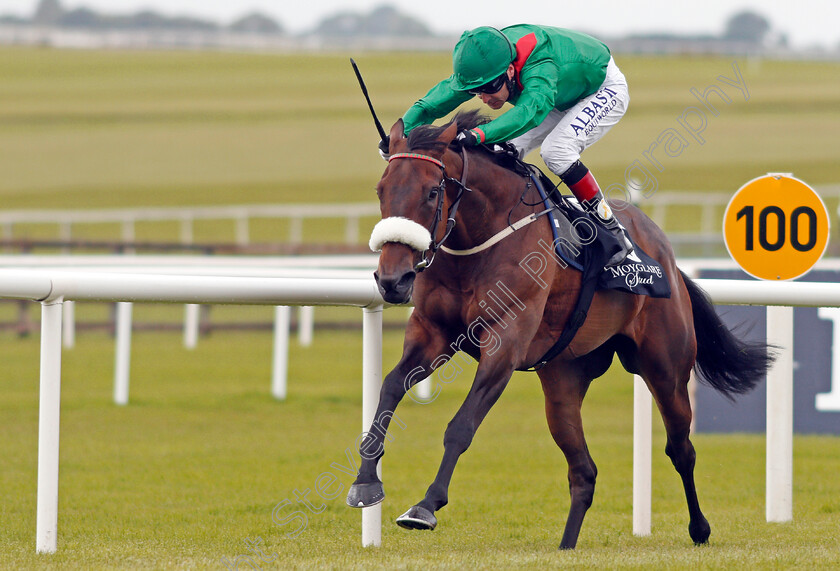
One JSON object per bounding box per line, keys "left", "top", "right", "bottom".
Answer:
{"left": 35, "top": 299, "right": 62, "bottom": 553}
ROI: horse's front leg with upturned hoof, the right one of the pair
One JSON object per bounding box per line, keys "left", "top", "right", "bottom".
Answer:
{"left": 397, "top": 356, "right": 514, "bottom": 529}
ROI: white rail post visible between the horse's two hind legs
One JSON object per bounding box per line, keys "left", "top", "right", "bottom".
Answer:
{"left": 633, "top": 375, "right": 653, "bottom": 535}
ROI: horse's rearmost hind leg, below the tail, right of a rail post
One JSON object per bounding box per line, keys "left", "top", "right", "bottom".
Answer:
{"left": 641, "top": 348, "right": 711, "bottom": 545}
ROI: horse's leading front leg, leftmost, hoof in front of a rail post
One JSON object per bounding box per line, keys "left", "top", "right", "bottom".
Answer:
{"left": 347, "top": 318, "right": 452, "bottom": 508}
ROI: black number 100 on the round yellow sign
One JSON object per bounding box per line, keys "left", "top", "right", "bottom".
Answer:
{"left": 736, "top": 206, "right": 817, "bottom": 252}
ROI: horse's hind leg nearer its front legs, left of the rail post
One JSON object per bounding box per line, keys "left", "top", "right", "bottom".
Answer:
{"left": 540, "top": 363, "right": 598, "bottom": 549}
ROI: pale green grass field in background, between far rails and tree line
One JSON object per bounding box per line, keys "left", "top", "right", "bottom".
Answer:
{"left": 0, "top": 48, "right": 840, "bottom": 228}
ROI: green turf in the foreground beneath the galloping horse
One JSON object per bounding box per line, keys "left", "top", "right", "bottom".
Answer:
{"left": 0, "top": 328, "right": 840, "bottom": 569}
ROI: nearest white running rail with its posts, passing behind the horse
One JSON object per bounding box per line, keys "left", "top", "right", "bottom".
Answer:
{"left": 0, "top": 269, "right": 840, "bottom": 553}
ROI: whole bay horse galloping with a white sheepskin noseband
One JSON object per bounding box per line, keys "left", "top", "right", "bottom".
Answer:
{"left": 347, "top": 108, "right": 772, "bottom": 549}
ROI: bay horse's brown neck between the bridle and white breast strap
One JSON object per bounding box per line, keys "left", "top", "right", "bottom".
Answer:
{"left": 453, "top": 153, "right": 525, "bottom": 248}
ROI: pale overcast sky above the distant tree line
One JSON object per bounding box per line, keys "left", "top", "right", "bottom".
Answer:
{"left": 0, "top": 0, "right": 840, "bottom": 48}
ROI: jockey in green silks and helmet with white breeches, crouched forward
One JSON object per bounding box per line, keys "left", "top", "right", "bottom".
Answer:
{"left": 388, "top": 24, "right": 635, "bottom": 265}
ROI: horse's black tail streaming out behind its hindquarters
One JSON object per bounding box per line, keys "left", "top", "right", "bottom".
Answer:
{"left": 680, "top": 272, "right": 775, "bottom": 400}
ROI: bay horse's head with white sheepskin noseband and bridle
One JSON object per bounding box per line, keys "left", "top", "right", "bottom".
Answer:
{"left": 370, "top": 119, "right": 458, "bottom": 303}
